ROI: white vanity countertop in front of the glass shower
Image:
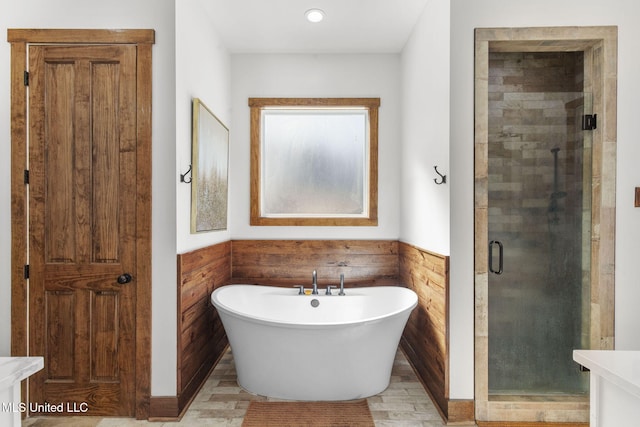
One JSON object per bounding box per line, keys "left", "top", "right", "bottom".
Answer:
{"left": 573, "top": 350, "right": 640, "bottom": 398}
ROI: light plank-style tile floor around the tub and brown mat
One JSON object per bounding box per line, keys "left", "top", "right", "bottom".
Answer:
{"left": 23, "top": 350, "right": 458, "bottom": 427}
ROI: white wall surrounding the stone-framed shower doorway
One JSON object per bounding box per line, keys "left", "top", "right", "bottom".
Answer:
{"left": 450, "top": 0, "right": 640, "bottom": 398}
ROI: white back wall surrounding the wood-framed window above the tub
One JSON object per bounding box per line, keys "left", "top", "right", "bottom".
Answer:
{"left": 229, "top": 54, "right": 400, "bottom": 239}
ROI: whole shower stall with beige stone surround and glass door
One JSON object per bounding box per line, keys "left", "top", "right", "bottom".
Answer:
{"left": 474, "top": 27, "right": 617, "bottom": 423}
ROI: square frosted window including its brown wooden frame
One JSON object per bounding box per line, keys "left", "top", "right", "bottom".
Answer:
{"left": 250, "top": 98, "right": 379, "bottom": 225}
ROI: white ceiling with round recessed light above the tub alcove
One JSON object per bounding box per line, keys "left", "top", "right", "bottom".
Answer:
{"left": 201, "top": 0, "right": 429, "bottom": 53}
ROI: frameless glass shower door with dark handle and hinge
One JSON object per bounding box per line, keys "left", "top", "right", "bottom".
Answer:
{"left": 488, "top": 92, "right": 591, "bottom": 396}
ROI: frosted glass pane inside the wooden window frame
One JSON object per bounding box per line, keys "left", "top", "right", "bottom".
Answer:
{"left": 262, "top": 109, "right": 369, "bottom": 217}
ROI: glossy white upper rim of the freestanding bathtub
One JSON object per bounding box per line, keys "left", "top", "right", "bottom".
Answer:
{"left": 210, "top": 283, "right": 418, "bottom": 329}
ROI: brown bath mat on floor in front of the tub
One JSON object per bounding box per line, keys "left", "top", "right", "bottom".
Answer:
{"left": 242, "top": 399, "right": 374, "bottom": 427}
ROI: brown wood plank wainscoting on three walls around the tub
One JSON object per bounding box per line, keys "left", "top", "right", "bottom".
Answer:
{"left": 151, "top": 240, "right": 474, "bottom": 423}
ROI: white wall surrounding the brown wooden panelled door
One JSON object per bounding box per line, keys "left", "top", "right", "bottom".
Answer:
{"left": 0, "top": 0, "right": 176, "bottom": 395}
